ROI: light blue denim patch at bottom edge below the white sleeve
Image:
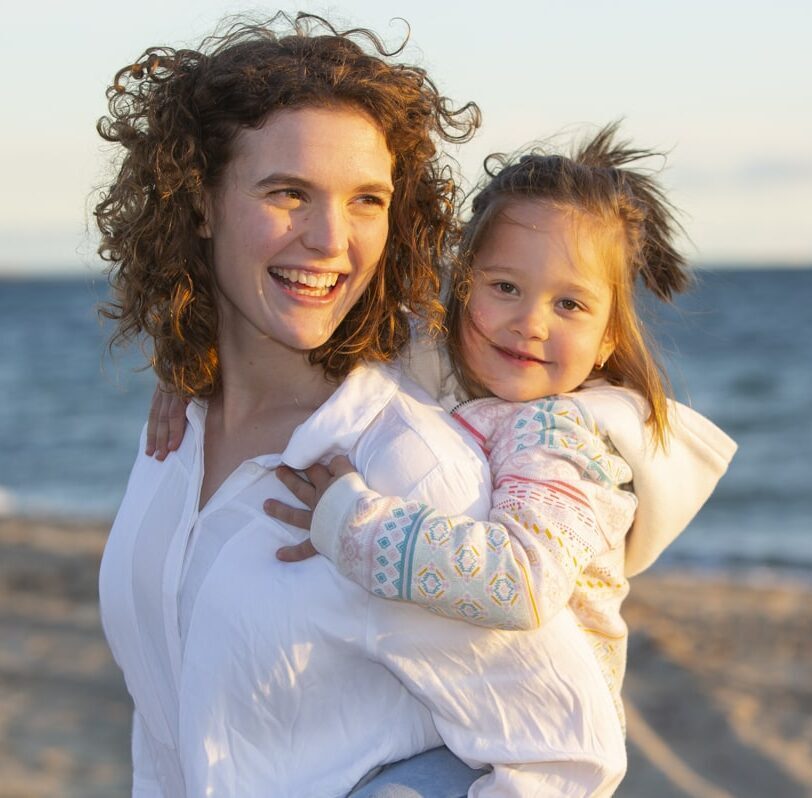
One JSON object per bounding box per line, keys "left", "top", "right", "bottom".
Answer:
{"left": 348, "top": 747, "right": 487, "bottom": 798}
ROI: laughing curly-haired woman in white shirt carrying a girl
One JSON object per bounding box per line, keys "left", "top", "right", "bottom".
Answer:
{"left": 96, "top": 17, "right": 625, "bottom": 798}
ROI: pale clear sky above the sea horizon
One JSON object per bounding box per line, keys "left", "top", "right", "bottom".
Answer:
{"left": 0, "top": 0, "right": 812, "bottom": 275}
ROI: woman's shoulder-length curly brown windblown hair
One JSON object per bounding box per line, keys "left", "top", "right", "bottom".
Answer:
{"left": 95, "top": 13, "right": 479, "bottom": 397}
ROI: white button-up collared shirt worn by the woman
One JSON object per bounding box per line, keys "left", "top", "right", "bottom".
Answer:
{"left": 100, "top": 366, "right": 625, "bottom": 798}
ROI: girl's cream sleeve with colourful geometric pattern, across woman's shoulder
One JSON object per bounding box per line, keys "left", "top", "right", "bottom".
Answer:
{"left": 312, "top": 399, "right": 636, "bottom": 629}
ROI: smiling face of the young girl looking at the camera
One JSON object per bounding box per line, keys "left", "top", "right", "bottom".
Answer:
{"left": 460, "top": 200, "right": 614, "bottom": 402}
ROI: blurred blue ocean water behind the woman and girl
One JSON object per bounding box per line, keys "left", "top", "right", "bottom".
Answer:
{"left": 0, "top": 268, "right": 812, "bottom": 577}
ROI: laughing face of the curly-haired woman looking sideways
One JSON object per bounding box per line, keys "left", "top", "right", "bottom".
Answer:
{"left": 201, "top": 108, "right": 393, "bottom": 351}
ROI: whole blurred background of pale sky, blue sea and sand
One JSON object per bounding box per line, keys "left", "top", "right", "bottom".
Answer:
{"left": 0, "top": 0, "right": 812, "bottom": 798}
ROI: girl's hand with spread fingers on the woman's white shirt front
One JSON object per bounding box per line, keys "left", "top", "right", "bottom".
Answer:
{"left": 270, "top": 455, "right": 355, "bottom": 562}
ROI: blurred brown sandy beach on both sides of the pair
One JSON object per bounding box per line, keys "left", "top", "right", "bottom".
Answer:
{"left": 0, "top": 518, "right": 812, "bottom": 798}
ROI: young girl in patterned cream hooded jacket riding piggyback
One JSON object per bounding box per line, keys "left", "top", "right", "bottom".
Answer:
{"left": 266, "top": 126, "right": 735, "bottom": 722}
